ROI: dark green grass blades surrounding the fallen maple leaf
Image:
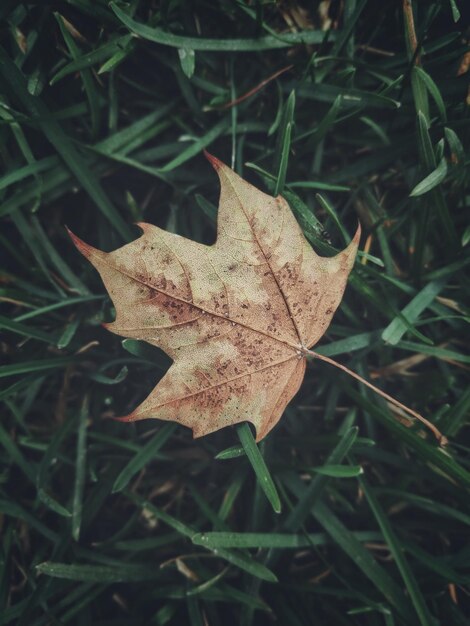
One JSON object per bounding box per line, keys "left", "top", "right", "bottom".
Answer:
{"left": 0, "top": 0, "right": 470, "bottom": 626}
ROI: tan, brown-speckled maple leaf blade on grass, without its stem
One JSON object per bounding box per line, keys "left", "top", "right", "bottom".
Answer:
{"left": 67, "top": 155, "right": 360, "bottom": 441}
